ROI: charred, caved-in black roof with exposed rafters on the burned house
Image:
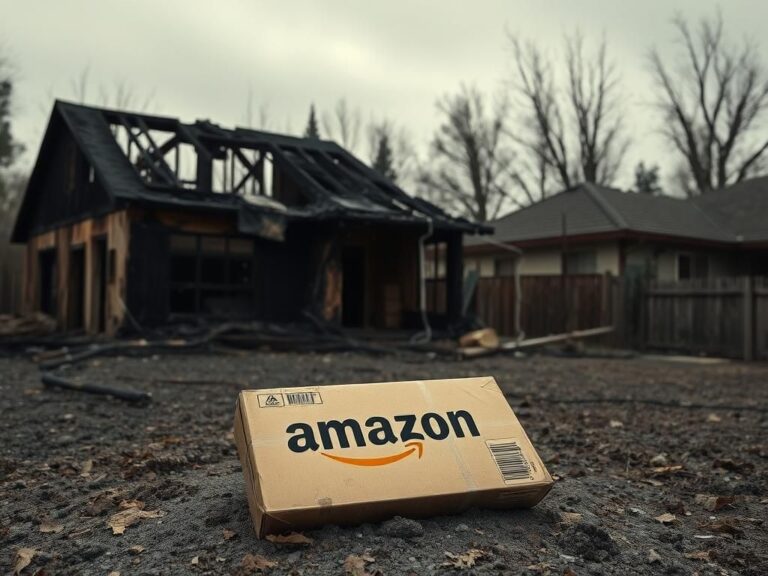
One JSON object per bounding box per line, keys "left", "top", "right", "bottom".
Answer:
{"left": 13, "top": 101, "right": 491, "bottom": 241}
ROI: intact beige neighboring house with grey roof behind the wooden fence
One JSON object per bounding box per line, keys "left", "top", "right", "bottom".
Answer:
{"left": 464, "top": 178, "right": 768, "bottom": 280}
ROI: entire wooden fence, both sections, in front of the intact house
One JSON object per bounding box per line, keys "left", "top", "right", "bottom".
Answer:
{"left": 427, "top": 275, "right": 768, "bottom": 360}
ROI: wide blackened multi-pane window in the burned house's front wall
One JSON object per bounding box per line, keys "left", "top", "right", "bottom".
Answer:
{"left": 170, "top": 234, "right": 255, "bottom": 317}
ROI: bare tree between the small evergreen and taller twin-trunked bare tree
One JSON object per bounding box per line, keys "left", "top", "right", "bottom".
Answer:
{"left": 421, "top": 86, "right": 513, "bottom": 222}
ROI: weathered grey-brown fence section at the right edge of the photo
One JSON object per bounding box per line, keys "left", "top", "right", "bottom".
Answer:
{"left": 643, "top": 277, "right": 768, "bottom": 360}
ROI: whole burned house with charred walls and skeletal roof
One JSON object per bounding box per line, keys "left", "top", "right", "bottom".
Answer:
{"left": 12, "top": 101, "right": 488, "bottom": 334}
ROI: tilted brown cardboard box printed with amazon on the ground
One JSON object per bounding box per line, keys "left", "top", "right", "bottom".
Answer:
{"left": 235, "top": 377, "right": 552, "bottom": 537}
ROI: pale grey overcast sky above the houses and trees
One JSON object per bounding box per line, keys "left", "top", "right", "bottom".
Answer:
{"left": 0, "top": 0, "right": 768, "bottom": 194}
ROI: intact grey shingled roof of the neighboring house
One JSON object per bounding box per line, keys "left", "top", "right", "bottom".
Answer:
{"left": 467, "top": 178, "right": 768, "bottom": 245}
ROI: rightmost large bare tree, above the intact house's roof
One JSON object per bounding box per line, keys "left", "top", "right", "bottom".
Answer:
{"left": 649, "top": 14, "right": 768, "bottom": 195}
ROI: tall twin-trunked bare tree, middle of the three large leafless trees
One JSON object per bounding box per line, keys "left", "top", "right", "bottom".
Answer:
{"left": 509, "top": 33, "right": 629, "bottom": 203}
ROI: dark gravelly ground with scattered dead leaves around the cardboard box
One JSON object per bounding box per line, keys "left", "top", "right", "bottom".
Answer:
{"left": 0, "top": 352, "right": 768, "bottom": 575}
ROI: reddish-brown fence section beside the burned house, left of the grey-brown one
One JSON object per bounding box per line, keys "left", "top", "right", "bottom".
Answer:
{"left": 427, "top": 274, "right": 619, "bottom": 337}
